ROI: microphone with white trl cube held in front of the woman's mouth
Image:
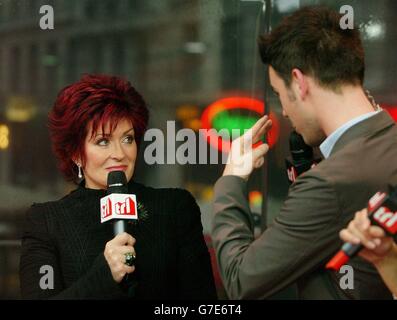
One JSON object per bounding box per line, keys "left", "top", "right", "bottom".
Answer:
{"left": 101, "top": 171, "right": 138, "bottom": 236}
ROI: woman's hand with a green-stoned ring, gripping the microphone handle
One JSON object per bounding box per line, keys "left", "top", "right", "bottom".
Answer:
{"left": 103, "top": 232, "right": 135, "bottom": 283}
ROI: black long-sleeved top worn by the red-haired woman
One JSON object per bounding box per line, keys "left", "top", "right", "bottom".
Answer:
{"left": 20, "top": 181, "right": 216, "bottom": 299}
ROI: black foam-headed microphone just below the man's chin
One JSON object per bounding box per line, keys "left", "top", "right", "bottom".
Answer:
{"left": 285, "top": 131, "right": 321, "bottom": 184}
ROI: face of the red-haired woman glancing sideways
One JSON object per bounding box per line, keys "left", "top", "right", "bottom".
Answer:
{"left": 83, "top": 119, "right": 137, "bottom": 189}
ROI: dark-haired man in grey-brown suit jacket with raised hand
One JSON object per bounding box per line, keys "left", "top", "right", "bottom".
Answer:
{"left": 212, "top": 7, "right": 397, "bottom": 299}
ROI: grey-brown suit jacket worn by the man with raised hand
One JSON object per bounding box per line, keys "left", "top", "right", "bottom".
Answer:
{"left": 212, "top": 111, "right": 397, "bottom": 299}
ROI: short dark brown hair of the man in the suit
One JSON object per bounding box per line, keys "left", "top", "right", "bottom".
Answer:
{"left": 259, "top": 6, "right": 365, "bottom": 91}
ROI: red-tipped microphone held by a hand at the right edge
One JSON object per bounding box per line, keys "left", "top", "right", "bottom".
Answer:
{"left": 325, "top": 187, "right": 397, "bottom": 271}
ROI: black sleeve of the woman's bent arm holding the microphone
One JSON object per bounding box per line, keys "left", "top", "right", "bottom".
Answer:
{"left": 20, "top": 205, "right": 126, "bottom": 299}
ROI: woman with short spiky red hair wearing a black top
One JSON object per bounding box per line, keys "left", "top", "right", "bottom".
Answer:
{"left": 20, "top": 75, "right": 216, "bottom": 299}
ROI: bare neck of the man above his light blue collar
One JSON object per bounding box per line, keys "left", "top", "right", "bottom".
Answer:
{"left": 313, "top": 86, "right": 375, "bottom": 137}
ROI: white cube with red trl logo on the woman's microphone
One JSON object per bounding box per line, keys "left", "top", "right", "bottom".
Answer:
{"left": 101, "top": 193, "right": 138, "bottom": 223}
